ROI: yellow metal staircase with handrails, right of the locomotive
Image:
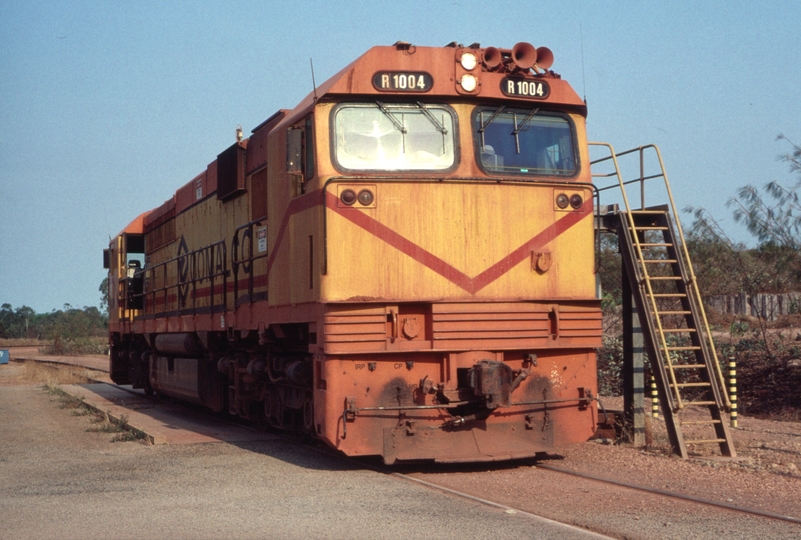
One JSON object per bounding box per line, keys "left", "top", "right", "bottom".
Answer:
{"left": 593, "top": 143, "right": 736, "bottom": 458}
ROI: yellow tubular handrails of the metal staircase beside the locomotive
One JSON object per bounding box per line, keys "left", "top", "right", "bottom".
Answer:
{"left": 588, "top": 142, "right": 731, "bottom": 408}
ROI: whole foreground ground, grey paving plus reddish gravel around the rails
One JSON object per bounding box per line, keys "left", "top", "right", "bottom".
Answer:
{"left": 0, "top": 358, "right": 801, "bottom": 539}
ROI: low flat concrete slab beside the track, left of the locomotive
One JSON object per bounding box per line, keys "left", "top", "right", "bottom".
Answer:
{"left": 61, "top": 383, "right": 277, "bottom": 444}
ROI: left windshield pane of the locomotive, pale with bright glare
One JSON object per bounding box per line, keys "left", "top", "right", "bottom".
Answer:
{"left": 334, "top": 101, "right": 455, "bottom": 171}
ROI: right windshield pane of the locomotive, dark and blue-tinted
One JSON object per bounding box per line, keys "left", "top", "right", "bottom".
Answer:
{"left": 473, "top": 106, "right": 576, "bottom": 176}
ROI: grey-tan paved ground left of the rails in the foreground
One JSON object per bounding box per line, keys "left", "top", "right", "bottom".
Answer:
{"left": 0, "top": 365, "right": 593, "bottom": 540}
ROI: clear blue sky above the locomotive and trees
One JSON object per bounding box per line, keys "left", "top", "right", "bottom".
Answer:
{"left": 0, "top": 0, "right": 801, "bottom": 312}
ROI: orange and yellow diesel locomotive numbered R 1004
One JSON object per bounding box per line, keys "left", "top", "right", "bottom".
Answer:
{"left": 106, "top": 42, "right": 601, "bottom": 463}
